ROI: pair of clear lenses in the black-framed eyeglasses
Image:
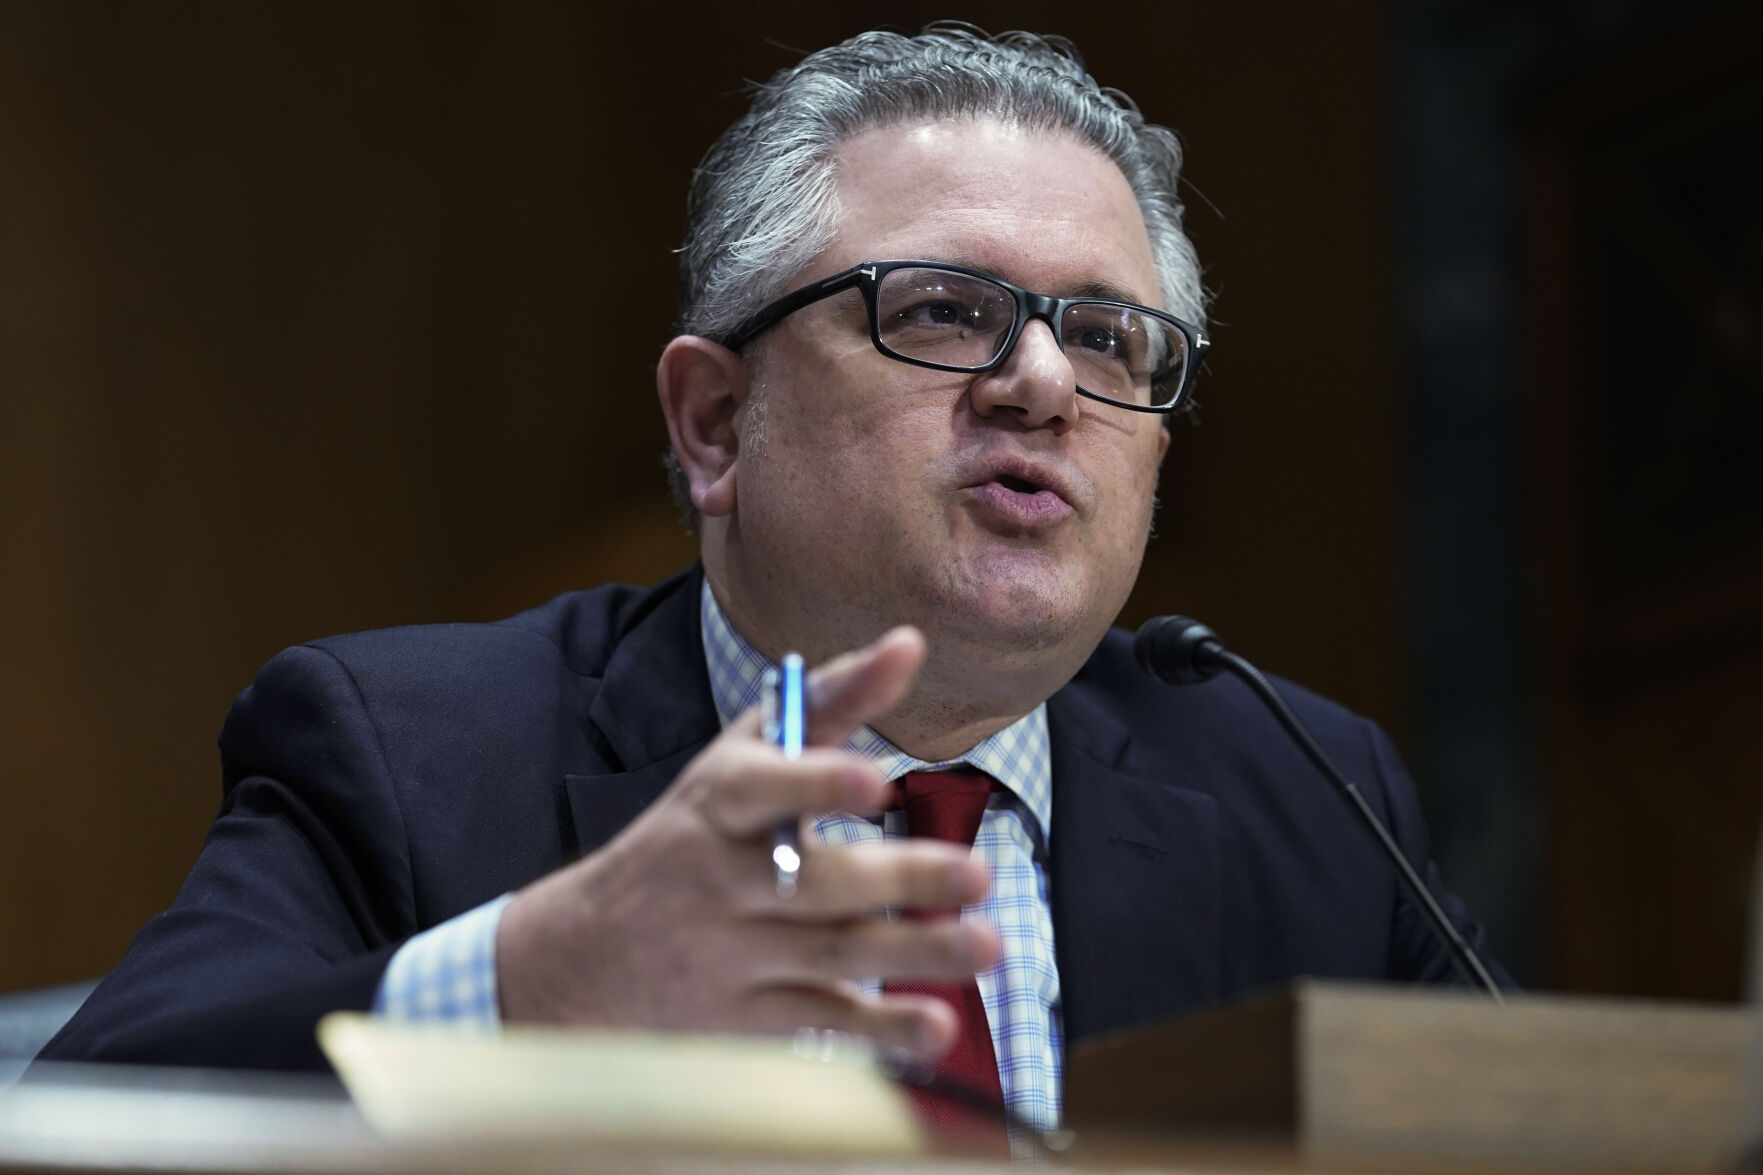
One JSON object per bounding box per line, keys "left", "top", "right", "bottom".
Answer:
{"left": 876, "top": 268, "right": 1186, "bottom": 408}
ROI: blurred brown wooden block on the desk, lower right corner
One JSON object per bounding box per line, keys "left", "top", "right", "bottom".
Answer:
{"left": 1065, "top": 979, "right": 1763, "bottom": 1170}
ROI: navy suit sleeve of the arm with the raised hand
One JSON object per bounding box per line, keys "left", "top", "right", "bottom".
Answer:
{"left": 41, "top": 647, "right": 418, "bottom": 1069}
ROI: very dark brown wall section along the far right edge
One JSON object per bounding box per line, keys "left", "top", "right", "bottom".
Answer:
{"left": 1527, "top": 4, "right": 1763, "bottom": 999}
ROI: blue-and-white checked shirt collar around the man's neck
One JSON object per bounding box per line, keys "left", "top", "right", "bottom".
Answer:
{"left": 700, "top": 579, "right": 1053, "bottom": 834}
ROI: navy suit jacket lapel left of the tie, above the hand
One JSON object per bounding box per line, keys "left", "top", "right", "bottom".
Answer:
{"left": 564, "top": 568, "right": 721, "bottom": 854}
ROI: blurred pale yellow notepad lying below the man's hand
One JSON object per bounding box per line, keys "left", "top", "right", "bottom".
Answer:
{"left": 319, "top": 1013, "right": 926, "bottom": 1156}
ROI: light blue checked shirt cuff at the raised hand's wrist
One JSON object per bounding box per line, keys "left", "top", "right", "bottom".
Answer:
{"left": 374, "top": 893, "right": 515, "bottom": 1029}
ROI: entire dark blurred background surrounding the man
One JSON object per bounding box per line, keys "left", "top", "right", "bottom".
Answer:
{"left": 0, "top": 0, "right": 1763, "bottom": 999}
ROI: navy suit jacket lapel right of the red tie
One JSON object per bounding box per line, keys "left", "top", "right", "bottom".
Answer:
{"left": 1047, "top": 685, "right": 1224, "bottom": 1041}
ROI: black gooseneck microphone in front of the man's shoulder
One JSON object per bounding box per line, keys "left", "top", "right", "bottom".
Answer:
{"left": 1132, "top": 616, "right": 1506, "bottom": 1004}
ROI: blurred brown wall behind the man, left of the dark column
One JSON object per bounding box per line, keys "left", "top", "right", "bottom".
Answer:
{"left": 0, "top": 0, "right": 1402, "bottom": 990}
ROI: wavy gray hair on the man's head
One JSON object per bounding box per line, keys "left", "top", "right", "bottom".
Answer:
{"left": 663, "top": 23, "right": 1206, "bottom": 529}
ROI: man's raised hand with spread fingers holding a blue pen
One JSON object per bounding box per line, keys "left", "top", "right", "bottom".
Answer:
{"left": 497, "top": 628, "right": 1000, "bottom": 1059}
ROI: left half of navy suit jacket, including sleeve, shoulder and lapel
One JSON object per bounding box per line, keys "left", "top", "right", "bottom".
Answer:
{"left": 42, "top": 568, "right": 718, "bottom": 1069}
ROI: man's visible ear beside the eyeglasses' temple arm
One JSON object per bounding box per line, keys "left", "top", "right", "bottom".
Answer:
{"left": 656, "top": 335, "right": 748, "bottom": 519}
